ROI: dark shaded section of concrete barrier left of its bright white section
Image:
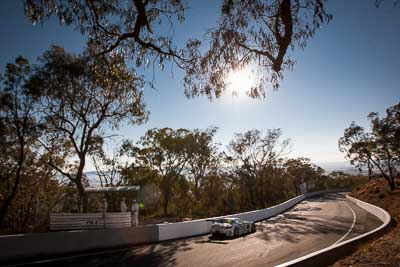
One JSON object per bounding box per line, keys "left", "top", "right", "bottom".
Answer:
{"left": 0, "top": 225, "right": 158, "bottom": 265}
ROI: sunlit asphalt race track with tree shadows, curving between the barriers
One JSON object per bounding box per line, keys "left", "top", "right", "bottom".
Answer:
{"left": 13, "top": 194, "right": 381, "bottom": 267}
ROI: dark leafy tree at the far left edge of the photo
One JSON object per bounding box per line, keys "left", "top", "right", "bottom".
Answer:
{"left": 0, "top": 57, "right": 69, "bottom": 233}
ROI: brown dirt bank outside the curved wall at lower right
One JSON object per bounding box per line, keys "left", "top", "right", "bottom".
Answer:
{"left": 333, "top": 180, "right": 400, "bottom": 267}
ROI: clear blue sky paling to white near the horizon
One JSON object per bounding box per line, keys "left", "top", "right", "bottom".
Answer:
{"left": 0, "top": 0, "right": 400, "bottom": 169}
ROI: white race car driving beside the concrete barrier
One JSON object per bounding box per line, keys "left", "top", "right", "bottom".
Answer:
{"left": 211, "top": 218, "right": 256, "bottom": 237}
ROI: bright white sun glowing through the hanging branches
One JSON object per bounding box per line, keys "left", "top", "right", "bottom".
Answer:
{"left": 226, "top": 67, "right": 254, "bottom": 95}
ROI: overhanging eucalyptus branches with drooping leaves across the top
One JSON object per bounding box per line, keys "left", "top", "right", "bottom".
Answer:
{"left": 24, "top": 0, "right": 332, "bottom": 98}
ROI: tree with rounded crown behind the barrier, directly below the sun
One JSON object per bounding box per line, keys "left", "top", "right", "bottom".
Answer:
{"left": 226, "top": 129, "right": 290, "bottom": 209}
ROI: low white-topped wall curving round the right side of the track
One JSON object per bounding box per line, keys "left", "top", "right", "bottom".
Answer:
{"left": 278, "top": 196, "right": 391, "bottom": 267}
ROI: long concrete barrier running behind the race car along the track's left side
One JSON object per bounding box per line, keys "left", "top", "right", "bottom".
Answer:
{"left": 0, "top": 190, "right": 343, "bottom": 262}
